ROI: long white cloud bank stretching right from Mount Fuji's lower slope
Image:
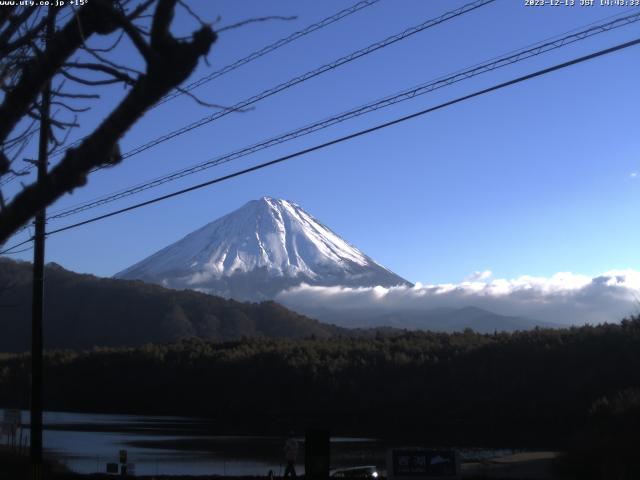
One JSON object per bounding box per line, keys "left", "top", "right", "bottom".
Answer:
{"left": 277, "top": 269, "right": 640, "bottom": 324}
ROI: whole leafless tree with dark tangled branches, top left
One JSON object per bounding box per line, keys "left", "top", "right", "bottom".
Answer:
{"left": 0, "top": 0, "right": 217, "bottom": 245}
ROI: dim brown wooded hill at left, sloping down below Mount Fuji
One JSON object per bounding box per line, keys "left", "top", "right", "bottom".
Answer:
{"left": 0, "top": 258, "right": 346, "bottom": 352}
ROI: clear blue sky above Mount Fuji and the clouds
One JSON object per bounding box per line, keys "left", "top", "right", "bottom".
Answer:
{"left": 1, "top": 0, "right": 640, "bottom": 283}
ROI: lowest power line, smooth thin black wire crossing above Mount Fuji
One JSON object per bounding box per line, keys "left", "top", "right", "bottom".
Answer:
{"left": 37, "top": 38, "right": 640, "bottom": 240}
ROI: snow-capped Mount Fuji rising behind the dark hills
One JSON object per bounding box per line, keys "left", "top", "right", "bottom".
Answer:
{"left": 115, "top": 197, "right": 410, "bottom": 300}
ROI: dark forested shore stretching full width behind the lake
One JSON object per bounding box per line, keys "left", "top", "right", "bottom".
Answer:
{"left": 0, "top": 319, "right": 640, "bottom": 450}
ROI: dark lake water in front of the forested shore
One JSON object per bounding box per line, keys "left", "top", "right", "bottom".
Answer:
{"left": 0, "top": 409, "right": 513, "bottom": 476}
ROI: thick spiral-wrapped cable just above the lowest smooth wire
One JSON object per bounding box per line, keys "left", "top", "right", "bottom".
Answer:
{"left": 49, "top": 8, "right": 640, "bottom": 220}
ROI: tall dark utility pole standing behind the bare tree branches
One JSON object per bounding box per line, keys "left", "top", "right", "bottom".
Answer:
{"left": 29, "top": 7, "right": 55, "bottom": 480}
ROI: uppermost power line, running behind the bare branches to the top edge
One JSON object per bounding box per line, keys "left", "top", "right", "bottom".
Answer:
{"left": 5, "top": 0, "right": 380, "bottom": 187}
